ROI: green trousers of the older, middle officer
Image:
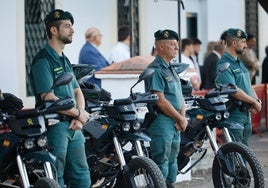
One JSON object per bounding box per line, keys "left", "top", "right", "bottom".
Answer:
{"left": 148, "top": 114, "right": 181, "bottom": 183}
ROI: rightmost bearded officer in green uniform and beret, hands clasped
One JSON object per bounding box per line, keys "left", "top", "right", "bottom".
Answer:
{"left": 216, "top": 28, "right": 262, "bottom": 145}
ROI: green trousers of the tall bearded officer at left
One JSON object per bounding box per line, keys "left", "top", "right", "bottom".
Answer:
{"left": 47, "top": 122, "right": 91, "bottom": 188}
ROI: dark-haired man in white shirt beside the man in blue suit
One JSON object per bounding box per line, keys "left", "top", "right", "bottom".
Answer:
{"left": 107, "top": 26, "right": 130, "bottom": 64}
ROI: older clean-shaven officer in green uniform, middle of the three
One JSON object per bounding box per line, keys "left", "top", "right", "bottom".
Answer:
{"left": 145, "top": 29, "right": 187, "bottom": 187}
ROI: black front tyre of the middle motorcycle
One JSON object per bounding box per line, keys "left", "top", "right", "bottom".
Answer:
{"left": 115, "top": 156, "right": 166, "bottom": 188}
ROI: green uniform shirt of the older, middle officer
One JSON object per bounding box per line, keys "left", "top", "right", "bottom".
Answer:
{"left": 145, "top": 56, "right": 183, "bottom": 110}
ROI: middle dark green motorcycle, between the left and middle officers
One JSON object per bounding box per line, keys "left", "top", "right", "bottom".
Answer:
{"left": 73, "top": 65, "right": 166, "bottom": 188}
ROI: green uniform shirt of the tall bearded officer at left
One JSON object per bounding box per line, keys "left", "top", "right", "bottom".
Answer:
{"left": 31, "top": 44, "right": 79, "bottom": 102}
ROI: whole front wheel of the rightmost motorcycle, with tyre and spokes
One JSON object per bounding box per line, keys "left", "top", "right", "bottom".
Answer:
{"left": 212, "top": 142, "right": 264, "bottom": 188}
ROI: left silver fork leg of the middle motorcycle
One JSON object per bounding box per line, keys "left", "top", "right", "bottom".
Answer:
{"left": 113, "top": 136, "right": 136, "bottom": 187}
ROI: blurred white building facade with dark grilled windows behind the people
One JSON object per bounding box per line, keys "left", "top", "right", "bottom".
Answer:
{"left": 0, "top": 0, "right": 268, "bottom": 107}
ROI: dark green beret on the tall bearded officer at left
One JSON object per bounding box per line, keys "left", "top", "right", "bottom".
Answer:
{"left": 45, "top": 9, "right": 74, "bottom": 24}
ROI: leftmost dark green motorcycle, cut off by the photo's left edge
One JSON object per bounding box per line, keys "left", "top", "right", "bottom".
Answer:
{"left": 0, "top": 73, "right": 74, "bottom": 188}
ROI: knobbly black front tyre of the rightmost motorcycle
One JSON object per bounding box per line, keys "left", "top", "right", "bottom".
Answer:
{"left": 212, "top": 142, "right": 265, "bottom": 188}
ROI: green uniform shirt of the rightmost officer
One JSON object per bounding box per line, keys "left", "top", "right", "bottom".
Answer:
{"left": 217, "top": 52, "right": 252, "bottom": 121}
